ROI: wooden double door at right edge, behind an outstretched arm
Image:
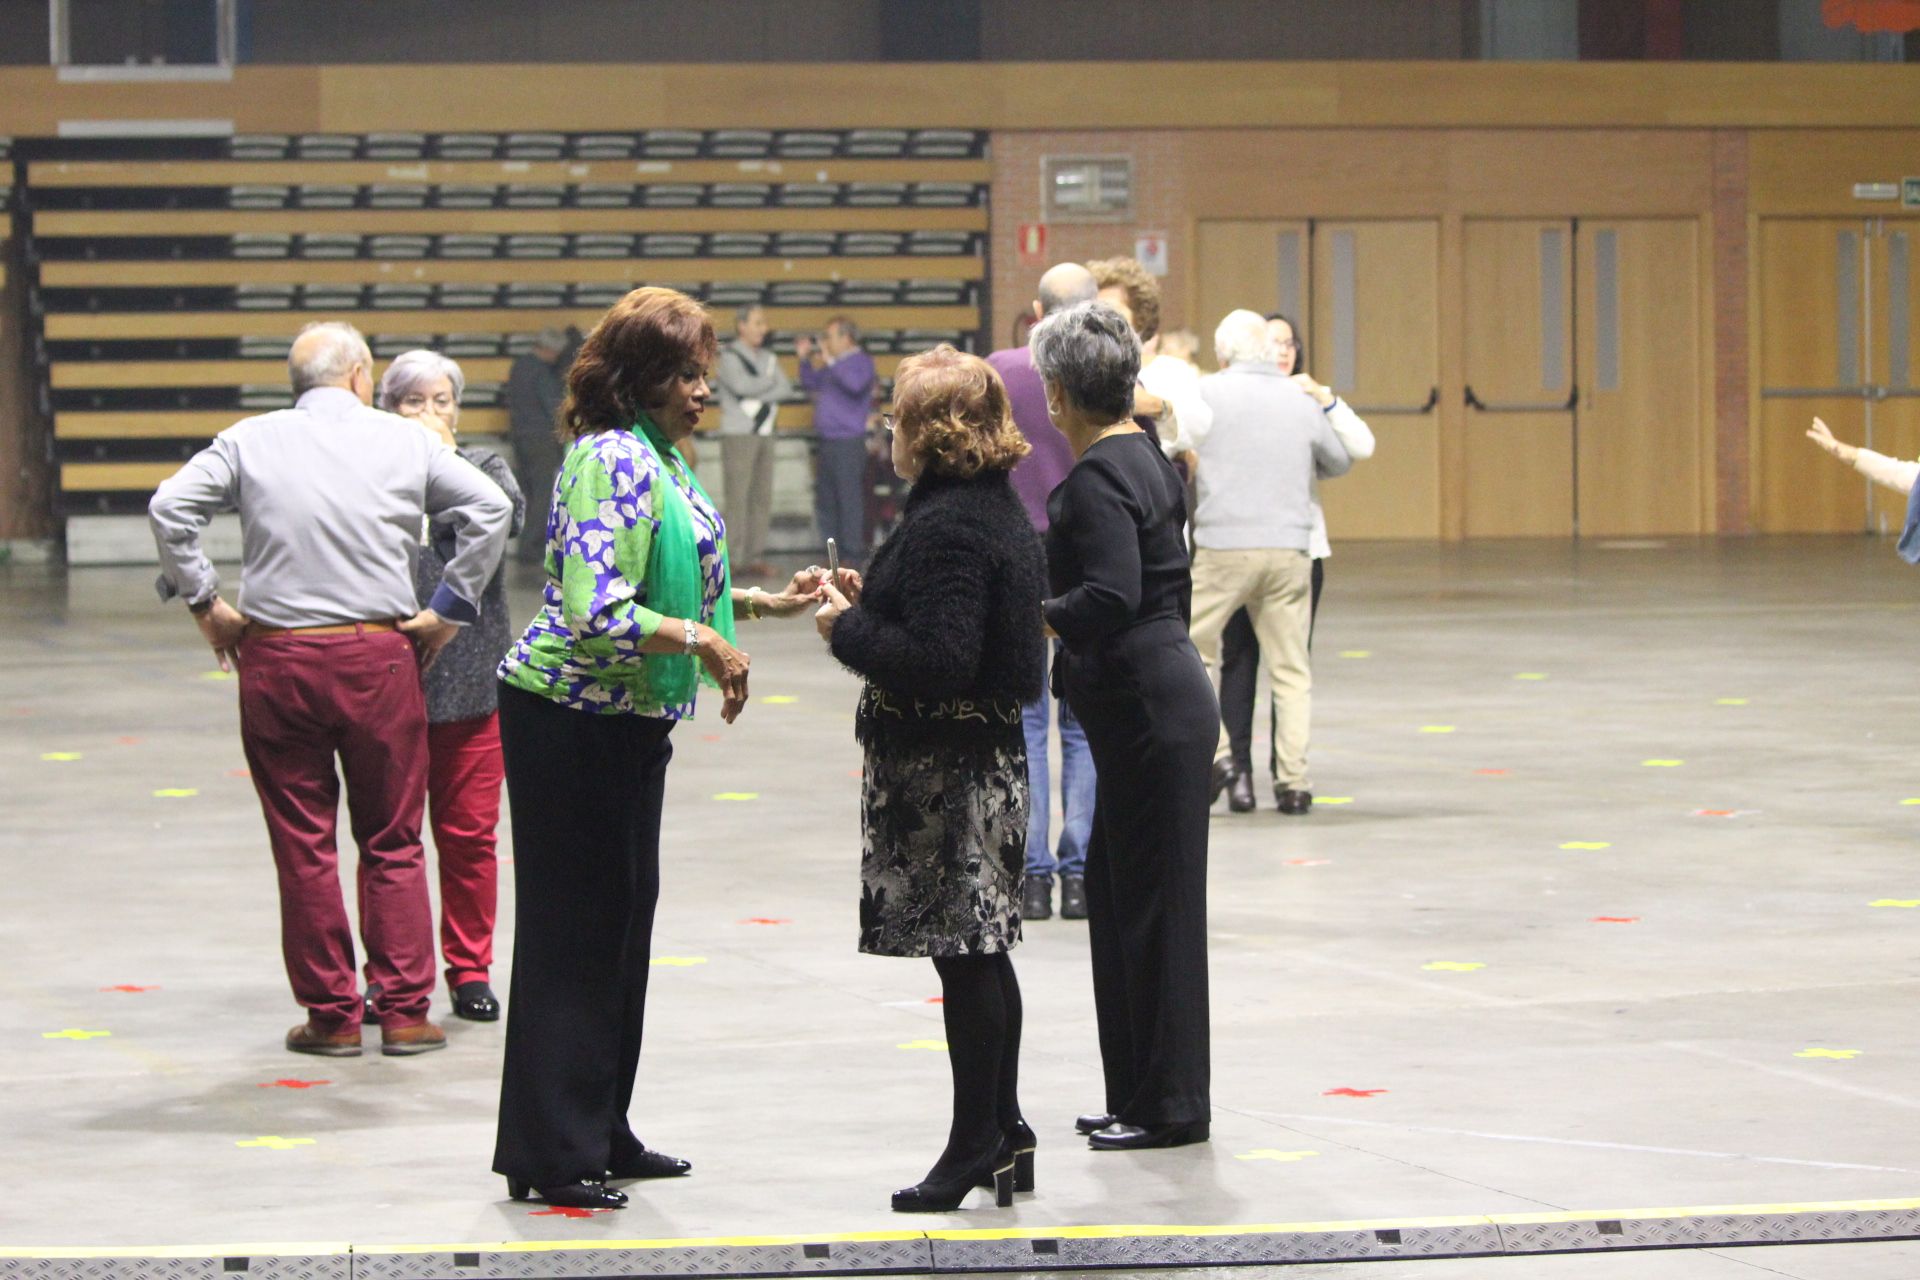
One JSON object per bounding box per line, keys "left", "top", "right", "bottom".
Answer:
{"left": 1755, "top": 219, "right": 1920, "bottom": 533}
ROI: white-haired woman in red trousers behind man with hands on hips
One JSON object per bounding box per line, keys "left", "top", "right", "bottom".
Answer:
{"left": 374, "top": 351, "right": 526, "bottom": 1023}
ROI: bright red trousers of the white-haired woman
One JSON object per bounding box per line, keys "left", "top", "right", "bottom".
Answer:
{"left": 426, "top": 712, "right": 505, "bottom": 990}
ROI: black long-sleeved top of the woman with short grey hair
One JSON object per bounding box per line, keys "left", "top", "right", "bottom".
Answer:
{"left": 1044, "top": 432, "right": 1192, "bottom": 651}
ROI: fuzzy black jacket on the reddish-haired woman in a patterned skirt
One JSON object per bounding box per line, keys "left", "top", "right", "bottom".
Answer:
{"left": 831, "top": 472, "right": 1046, "bottom": 743}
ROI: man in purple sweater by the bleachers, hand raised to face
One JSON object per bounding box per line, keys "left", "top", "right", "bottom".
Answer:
{"left": 793, "top": 315, "right": 876, "bottom": 568}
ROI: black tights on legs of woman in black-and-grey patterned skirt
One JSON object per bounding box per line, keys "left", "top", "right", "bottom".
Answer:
{"left": 927, "top": 952, "right": 1020, "bottom": 1180}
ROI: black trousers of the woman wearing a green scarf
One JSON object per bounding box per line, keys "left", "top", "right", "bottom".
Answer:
{"left": 493, "top": 687, "right": 674, "bottom": 1186}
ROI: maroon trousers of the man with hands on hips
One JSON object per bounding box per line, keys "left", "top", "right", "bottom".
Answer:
{"left": 240, "top": 631, "right": 434, "bottom": 1032}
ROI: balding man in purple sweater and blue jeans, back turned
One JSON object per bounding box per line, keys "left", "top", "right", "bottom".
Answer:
{"left": 987, "top": 263, "right": 1100, "bottom": 919}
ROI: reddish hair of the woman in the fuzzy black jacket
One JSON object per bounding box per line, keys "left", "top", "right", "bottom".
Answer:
{"left": 893, "top": 342, "right": 1031, "bottom": 480}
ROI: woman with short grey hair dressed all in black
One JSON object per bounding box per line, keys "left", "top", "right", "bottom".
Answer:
{"left": 1033, "top": 301, "right": 1219, "bottom": 1150}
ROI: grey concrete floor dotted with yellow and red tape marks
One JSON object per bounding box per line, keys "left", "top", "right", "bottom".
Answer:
{"left": 0, "top": 539, "right": 1920, "bottom": 1280}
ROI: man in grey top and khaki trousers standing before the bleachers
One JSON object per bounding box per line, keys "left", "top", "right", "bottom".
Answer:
{"left": 714, "top": 303, "right": 793, "bottom": 578}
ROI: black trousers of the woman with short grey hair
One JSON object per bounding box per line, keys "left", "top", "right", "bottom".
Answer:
{"left": 1064, "top": 620, "right": 1219, "bottom": 1126}
